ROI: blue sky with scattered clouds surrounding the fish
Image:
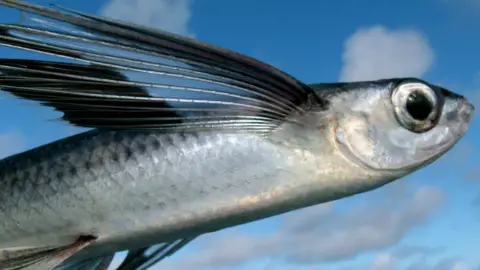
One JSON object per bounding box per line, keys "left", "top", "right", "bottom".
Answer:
{"left": 0, "top": 0, "right": 480, "bottom": 270}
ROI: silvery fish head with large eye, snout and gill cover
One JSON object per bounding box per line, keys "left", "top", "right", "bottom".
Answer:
{"left": 317, "top": 78, "right": 474, "bottom": 174}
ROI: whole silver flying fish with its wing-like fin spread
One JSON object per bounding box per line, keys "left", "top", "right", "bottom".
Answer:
{"left": 0, "top": 0, "right": 474, "bottom": 269}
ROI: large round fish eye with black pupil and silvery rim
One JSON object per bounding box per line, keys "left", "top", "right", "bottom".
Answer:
{"left": 392, "top": 82, "right": 441, "bottom": 133}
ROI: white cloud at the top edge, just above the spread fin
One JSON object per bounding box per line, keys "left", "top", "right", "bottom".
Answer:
{"left": 101, "top": 0, "right": 194, "bottom": 37}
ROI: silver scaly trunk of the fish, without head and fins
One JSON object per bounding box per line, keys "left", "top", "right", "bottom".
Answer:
{"left": 0, "top": 119, "right": 386, "bottom": 258}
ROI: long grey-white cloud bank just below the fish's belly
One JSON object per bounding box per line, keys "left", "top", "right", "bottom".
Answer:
{"left": 159, "top": 183, "right": 443, "bottom": 270}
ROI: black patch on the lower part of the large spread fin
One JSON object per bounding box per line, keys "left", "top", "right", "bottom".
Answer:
{"left": 0, "top": 59, "right": 181, "bottom": 127}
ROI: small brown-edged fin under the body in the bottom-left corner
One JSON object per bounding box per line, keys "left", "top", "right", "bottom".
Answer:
{"left": 0, "top": 236, "right": 96, "bottom": 270}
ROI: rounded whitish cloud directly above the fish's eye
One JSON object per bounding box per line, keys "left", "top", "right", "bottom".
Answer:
{"left": 340, "top": 26, "right": 434, "bottom": 81}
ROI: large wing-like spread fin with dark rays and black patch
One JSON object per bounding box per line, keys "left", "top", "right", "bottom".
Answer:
{"left": 0, "top": 0, "right": 322, "bottom": 132}
